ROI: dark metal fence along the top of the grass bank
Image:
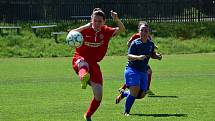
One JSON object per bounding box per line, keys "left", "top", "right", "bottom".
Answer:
{"left": 0, "top": 0, "right": 215, "bottom": 22}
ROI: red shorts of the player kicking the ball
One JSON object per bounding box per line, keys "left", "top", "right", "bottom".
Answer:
{"left": 72, "top": 56, "right": 103, "bottom": 85}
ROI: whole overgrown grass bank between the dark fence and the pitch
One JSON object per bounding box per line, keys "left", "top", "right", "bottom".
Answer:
{"left": 0, "top": 20, "right": 215, "bottom": 58}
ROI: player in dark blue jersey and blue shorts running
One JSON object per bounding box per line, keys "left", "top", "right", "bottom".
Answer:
{"left": 116, "top": 22, "right": 162, "bottom": 116}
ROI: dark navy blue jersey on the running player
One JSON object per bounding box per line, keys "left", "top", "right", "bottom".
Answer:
{"left": 127, "top": 38, "right": 155, "bottom": 73}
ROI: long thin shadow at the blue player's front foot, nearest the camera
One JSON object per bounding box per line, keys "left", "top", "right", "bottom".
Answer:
{"left": 130, "top": 114, "right": 187, "bottom": 117}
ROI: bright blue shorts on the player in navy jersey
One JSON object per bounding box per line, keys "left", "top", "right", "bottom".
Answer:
{"left": 125, "top": 67, "right": 148, "bottom": 92}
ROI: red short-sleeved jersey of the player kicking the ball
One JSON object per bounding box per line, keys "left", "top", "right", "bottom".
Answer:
{"left": 74, "top": 26, "right": 116, "bottom": 62}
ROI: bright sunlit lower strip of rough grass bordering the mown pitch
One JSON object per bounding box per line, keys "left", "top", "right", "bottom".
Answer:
{"left": 0, "top": 31, "right": 215, "bottom": 58}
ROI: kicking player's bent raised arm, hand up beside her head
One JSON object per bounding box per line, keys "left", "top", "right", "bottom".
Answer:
{"left": 110, "top": 10, "right": 126, "bottom": 35}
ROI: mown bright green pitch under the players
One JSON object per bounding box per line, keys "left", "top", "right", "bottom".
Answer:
{"left": 0, "top": 53, "right": 215, "bottom": 121}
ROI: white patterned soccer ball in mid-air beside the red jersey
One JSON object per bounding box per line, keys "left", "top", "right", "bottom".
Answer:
{"left": 66, "top": 31, "right": 83, "bottom": 48}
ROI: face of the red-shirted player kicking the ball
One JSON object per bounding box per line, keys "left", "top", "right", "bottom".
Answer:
{"left": 91, "top": 15, "right": 105, "bottom": 30}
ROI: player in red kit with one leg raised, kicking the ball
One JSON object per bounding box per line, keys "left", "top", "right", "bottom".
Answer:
{"left": 72, "top": 8, "right": 125, "bottom": 121}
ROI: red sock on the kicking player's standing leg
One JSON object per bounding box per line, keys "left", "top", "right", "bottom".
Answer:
{"left": 85, "top": 98, "right": 101, "bottom": 117}
